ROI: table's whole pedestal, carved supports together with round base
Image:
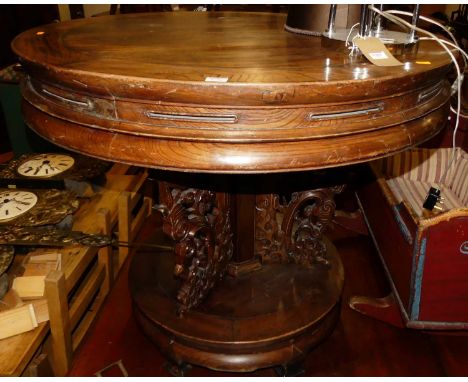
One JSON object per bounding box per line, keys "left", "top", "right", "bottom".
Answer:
{"left": 129, "top": 176, "right": 344, "bottom": 372}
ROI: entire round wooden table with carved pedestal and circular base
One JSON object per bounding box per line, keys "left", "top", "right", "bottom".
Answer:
{"left": 12, "top": 12, "right": 450, "bottom": 371}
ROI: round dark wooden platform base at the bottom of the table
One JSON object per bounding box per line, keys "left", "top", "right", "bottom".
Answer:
{"left": 129, "top": 243, "right": 343, "bottom": 372}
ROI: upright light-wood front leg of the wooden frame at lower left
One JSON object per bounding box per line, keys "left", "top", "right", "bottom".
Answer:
{"left": 45, "top": 271, "right": 73, "bottom": 376}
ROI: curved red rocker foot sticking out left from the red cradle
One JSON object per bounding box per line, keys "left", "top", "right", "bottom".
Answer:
{"left": 349, "top": 293, "right": 406, "bottom": 328}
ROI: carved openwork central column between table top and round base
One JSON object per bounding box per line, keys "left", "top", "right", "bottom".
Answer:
{"left": 152, "top": 172, "right": 344, "bottom": 314}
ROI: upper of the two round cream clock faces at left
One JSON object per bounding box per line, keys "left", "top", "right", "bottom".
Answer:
{"left": 17, "top": 154, "right": 75, "bottom": 178}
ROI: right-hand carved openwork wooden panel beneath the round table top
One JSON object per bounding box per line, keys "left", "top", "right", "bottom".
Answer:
{"left": 255, "top": 186, "right": 344, "bottom": 266}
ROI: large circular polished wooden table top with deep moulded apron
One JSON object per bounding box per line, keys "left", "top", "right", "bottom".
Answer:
{"left": 12, "top": 12, "right": 450, "bottom": 173}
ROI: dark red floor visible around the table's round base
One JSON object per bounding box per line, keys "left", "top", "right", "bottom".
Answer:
{"left": 69, "top": 222, "right": 468, "bottom": 377}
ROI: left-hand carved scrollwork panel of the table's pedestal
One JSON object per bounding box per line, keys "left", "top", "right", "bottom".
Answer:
{"left": 160, "top": 182, "right": 233, "bottom": 313}
